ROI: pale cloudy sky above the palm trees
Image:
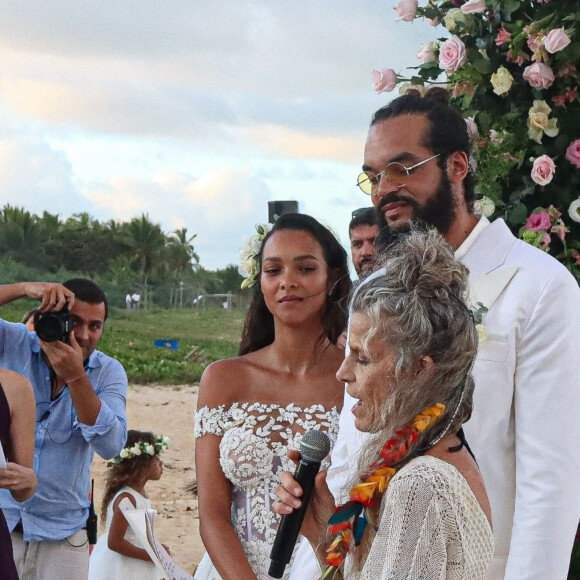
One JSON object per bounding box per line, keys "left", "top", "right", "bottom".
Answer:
{"left": 0, "top": 0, "right": 441, "bottom": 269}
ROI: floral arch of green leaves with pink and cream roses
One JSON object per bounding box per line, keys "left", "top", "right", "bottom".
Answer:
{"left": 388, "top": 0, "right": 580, "bottom": 280}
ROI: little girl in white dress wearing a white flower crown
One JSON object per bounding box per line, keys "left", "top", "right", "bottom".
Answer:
{"left": 89, "top": 430, "right": 168, "bottom": 580}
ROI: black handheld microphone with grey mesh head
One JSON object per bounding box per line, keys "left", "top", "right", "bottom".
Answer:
{"left": 268, "top": 429, "right": 330, "bottom": 578}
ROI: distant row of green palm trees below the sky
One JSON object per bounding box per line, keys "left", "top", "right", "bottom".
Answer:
{"left": 0, "top": 205, "right": 247, "bottom": 308}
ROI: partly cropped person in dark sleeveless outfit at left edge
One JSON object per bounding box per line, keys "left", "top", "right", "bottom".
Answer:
{"left": 0, "top": 368, "right": 37, "bottom": 580}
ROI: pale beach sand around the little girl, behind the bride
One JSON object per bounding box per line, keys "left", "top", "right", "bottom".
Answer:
{"left": 92, "top": 385, "right": 205, "bottom": 574}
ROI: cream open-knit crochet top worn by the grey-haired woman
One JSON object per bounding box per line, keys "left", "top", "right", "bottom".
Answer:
{"left": 358, "top": 455, "right": 494, "bottom": 580}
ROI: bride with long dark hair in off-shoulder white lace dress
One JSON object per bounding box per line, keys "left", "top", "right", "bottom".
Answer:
{"left": 195, "top": 214, "right": 350, "bottom": 580}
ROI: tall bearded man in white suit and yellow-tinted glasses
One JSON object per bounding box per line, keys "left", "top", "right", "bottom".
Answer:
{"left": 292, "top": 96, "right": 580, "bottom": 580}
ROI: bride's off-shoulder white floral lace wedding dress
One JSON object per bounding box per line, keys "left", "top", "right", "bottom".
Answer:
{"left": 194, "top": 403, "right": 339, "bottom": 580}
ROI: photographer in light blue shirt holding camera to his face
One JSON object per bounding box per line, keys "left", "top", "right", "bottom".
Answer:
{"left": 0, "top": 278, "right": 127, "bottom": 580}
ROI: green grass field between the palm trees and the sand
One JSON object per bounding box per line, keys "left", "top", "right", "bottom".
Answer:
{"left": 0, "top": 301, "right": 245, "bottom": 384}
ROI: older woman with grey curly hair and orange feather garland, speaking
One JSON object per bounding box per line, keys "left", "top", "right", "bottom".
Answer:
{"left": 274, "top": 230, "right": 493, "bottom": 580}
